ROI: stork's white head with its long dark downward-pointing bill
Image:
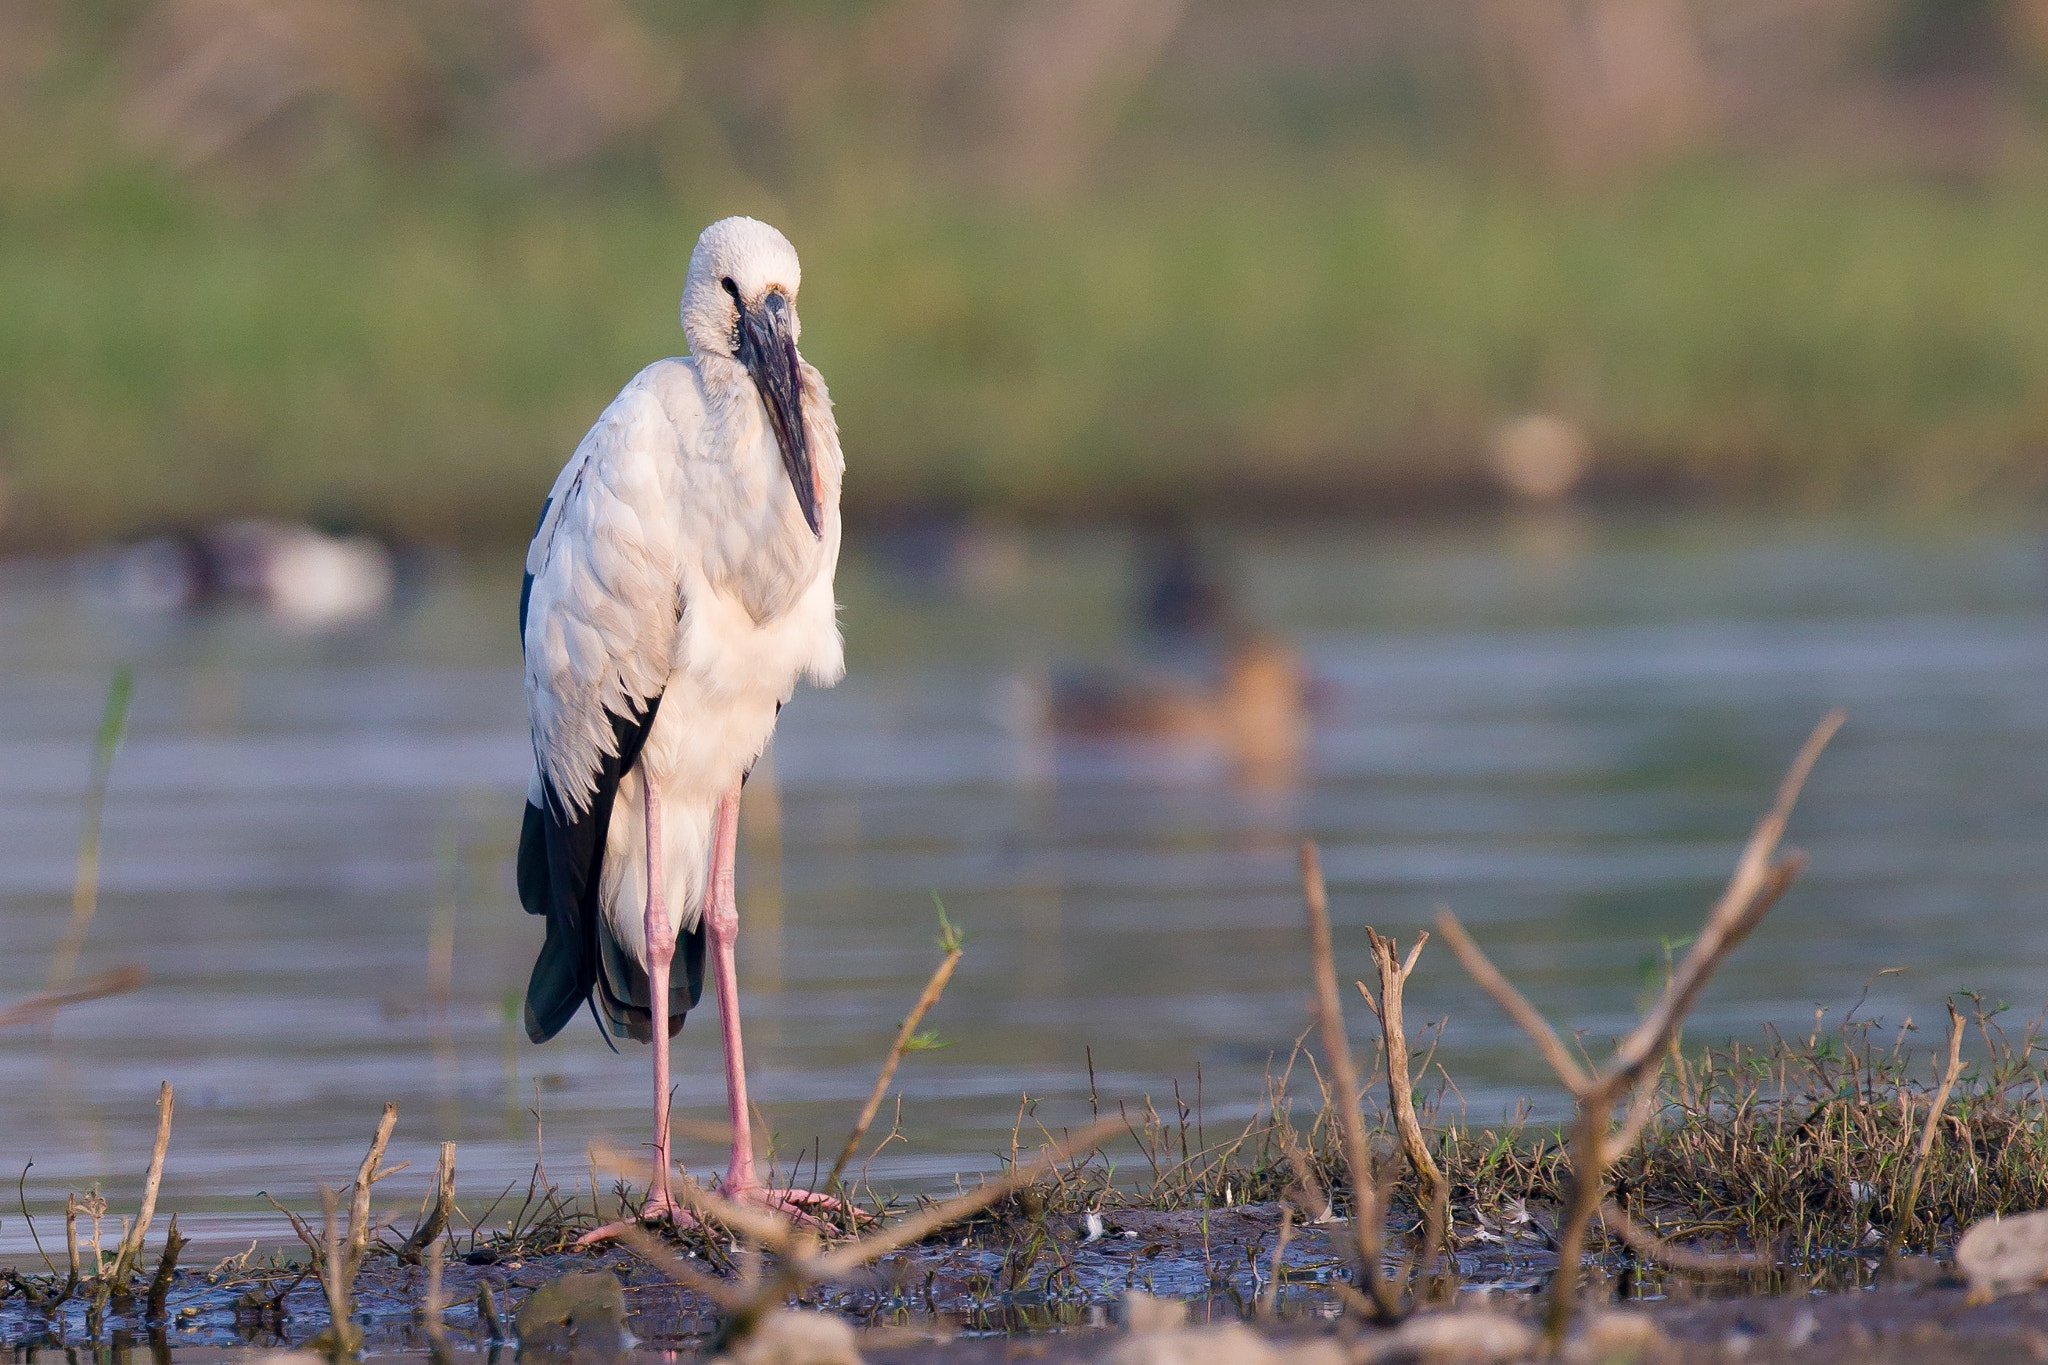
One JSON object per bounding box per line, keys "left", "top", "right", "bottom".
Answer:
{"left": 682, "top": 217, "right": 825, "bottom": 536}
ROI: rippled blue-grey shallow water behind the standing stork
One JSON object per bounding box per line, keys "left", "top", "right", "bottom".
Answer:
{"left": 0, "top": 516, "right": 2048, "bottom": 1254}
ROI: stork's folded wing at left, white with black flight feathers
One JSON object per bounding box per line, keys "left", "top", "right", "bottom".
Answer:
{"left": 518, "top": 381, "right": 688, "bottom": 1042}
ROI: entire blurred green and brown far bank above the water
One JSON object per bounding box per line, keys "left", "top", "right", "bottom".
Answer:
{"left": 0, "top": 0, "right": 2048, "bottom": 548}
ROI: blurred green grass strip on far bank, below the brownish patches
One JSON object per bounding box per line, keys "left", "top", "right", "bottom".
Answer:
{"left": 0, "top": 164, "right": 2048, "bottom": 546}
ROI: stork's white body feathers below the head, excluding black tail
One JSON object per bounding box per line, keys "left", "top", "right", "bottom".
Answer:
{"left": 526, "top": 356, "right": 846, "bottom": 908}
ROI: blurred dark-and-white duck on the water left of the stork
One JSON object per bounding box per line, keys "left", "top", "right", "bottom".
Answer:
{"left": 109, "top": 518, "right": 397, "bottom": 630}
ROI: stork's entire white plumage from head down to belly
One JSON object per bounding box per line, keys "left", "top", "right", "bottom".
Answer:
{"left": 522, "top": 219, "right": 846, "bottom": 1227}
